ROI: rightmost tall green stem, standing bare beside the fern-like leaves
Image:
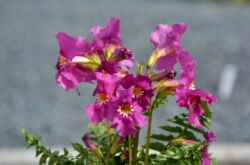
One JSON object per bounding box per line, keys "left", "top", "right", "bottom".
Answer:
{"left": 144, "top": 102, "right": 154, "bottom": 165}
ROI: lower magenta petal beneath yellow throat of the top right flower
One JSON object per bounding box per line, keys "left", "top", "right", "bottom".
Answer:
{"left": 156, "top": 54, "right": 177, "bottom": 71}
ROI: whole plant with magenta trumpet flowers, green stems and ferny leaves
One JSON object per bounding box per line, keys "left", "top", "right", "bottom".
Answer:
{"left": 22, "top": 18, "right": 216, "bottom": 165}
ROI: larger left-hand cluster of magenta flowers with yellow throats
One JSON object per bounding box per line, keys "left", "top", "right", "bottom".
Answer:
{"left": 56, "top": 18, "right": 153, "bottom": 136}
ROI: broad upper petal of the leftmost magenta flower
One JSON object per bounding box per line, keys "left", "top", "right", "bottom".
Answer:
{"left": 56, "top": 32, "right": 89, "bottom": 60}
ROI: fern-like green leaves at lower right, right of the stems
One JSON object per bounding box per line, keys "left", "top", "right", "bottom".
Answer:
{"left": 146, "top": 102, "right": 215, "bottom": 165}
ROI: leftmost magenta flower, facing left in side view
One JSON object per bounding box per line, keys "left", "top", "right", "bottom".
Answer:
{"left": 56, "top": 32, "right": 94, "bottom": 90}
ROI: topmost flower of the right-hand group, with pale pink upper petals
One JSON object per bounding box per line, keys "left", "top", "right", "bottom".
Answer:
{"left": 150, "top": 23, "right": 187, "bottom": 71}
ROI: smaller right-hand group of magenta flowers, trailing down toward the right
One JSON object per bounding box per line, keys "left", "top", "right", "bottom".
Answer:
{"left": 151, "top": 23, "right": 216, "bottom": 129}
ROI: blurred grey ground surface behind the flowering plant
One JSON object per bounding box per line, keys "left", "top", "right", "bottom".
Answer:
{"left": 0, "top": 0, "right": 250, "bottom": 164}
